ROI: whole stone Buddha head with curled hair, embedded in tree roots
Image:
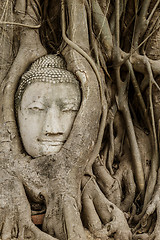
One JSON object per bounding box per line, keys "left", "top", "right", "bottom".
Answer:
{"left": 15, "top": 55, "right": 81, "bottom": 158}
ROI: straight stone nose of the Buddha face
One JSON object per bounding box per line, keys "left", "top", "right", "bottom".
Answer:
{"left": 43, "top": 105, "right": 64, "bottom": 135}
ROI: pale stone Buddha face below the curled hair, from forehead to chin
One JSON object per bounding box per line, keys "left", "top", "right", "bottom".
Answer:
{"left": 18, "top": 82, "right": 80, "bottom": 157}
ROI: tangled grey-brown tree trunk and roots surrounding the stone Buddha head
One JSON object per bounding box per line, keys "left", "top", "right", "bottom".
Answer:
{"left": 0, "top": 0, "right": 160, "bottom": 240}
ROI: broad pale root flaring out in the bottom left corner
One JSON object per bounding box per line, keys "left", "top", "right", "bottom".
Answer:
{"left": 0, "top": 169, "right": 57, "bottom": 240}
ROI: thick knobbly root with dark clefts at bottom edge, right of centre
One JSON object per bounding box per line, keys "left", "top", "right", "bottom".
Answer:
{"left": 82, "top": 176, "right": 131, "bottom": 240}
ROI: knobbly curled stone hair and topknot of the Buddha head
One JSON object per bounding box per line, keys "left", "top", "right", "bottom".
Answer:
{"left": 15, "top": 54, "right": 79, "bottom": 112}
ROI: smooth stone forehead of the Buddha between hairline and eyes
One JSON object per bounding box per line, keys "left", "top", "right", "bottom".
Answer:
{"left": 21, "top": 82, "right": 81, "bottom": 104}
